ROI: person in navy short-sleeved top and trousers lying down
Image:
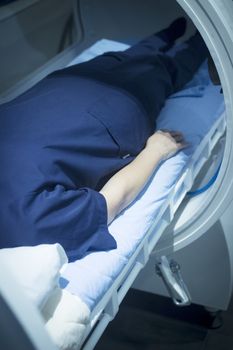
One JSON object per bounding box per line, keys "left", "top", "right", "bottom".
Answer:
{"left": 0, "top": 18, "right": 208, "bottom": 261}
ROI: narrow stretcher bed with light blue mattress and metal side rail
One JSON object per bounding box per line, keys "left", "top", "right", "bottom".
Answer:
{"left": 33, "top": 40, "right": 225, "bottom": 350}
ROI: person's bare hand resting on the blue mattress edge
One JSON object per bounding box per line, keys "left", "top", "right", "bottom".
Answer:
{"left": 145, "top": 130, "right": 187, "bottom": 160}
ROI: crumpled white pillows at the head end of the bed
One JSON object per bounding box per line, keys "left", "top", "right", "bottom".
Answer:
{"left": 0, "top": 244, "right": 90, "bottom": 350}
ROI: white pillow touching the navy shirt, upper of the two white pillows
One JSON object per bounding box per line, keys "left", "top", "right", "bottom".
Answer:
{"left": 0, "top": 244, "right": 68, "bottom": 309}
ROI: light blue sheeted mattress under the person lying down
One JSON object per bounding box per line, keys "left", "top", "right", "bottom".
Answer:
{"left": 60, "top": 39, "right": 224, "bottom": 311}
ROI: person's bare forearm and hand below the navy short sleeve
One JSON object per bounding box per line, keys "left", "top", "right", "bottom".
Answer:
{"left": 100, "top": 131, "right": 186, "bottom": 223}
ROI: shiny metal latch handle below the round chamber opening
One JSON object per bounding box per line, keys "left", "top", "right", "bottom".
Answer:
{"left": 155, "top": 256, "right": 191, "bottom": 306}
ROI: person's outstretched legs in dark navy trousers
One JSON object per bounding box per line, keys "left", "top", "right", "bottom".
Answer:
{"left": 55, "top": 22, "right": 208, "bottom": 123}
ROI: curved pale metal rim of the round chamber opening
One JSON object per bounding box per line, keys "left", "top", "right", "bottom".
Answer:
{"left": 159, "top": 0, "right": 233, "bottom": 252}
